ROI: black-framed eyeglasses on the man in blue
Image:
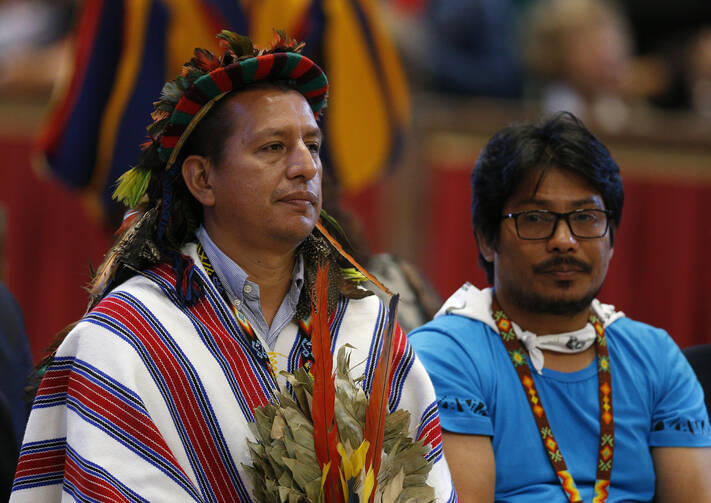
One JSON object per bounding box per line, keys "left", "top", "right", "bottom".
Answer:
{"left": 501, "top": 209, "right": 612, "bottom": 239}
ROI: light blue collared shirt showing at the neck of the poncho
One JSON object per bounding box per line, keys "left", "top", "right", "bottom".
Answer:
{"left": 196, "top": 225, "right": 304, "bottom": 349}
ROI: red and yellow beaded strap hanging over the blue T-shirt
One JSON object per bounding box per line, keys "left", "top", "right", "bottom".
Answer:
{"left": 492, "top": 298, "right": 615, "bottom": 503}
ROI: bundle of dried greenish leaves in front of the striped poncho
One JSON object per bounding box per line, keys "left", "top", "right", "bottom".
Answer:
{"left": 245, "top": 340, "right": 434, "bottom": 503}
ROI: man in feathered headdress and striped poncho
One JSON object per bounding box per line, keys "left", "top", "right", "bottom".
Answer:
{"left": 11, "top": 32, "right": 456, "bottom": 502}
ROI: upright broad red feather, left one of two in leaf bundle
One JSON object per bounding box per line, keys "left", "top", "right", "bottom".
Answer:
{"left": 311, "top": 264, "right": 343, "bottom": 503}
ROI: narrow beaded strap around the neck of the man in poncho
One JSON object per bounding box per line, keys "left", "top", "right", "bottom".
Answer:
{"left": 197, "top": 242, "right": 314, "bottom": 378}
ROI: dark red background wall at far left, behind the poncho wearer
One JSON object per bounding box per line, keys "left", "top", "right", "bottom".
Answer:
{"left": 0, "top": 136, "right": 112, "bottom": 360}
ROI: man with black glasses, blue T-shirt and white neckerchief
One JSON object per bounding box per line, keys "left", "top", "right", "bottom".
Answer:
{"left": 410, "top": 113, "right": 711, "bottom": 503}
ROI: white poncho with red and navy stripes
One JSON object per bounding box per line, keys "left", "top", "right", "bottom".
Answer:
{"left": 11, "top": 245, "right": 456, "bottom": 502}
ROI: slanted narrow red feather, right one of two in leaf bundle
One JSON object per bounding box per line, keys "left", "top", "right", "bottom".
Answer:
{"left": 363, "top": 295, "right": 400, "bottom": 502}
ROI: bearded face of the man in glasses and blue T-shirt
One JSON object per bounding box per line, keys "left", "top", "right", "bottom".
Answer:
{"left": 482, "top": 167, "right": 612, "bottom": 315}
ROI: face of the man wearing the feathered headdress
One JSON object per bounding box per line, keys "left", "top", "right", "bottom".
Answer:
{"left": 204, "top": 88, "right": 321, "bottom": 251}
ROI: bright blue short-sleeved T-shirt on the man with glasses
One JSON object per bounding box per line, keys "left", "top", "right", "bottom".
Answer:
{"left": 409, "top": 315, "right": 711, "bottom": 503}
